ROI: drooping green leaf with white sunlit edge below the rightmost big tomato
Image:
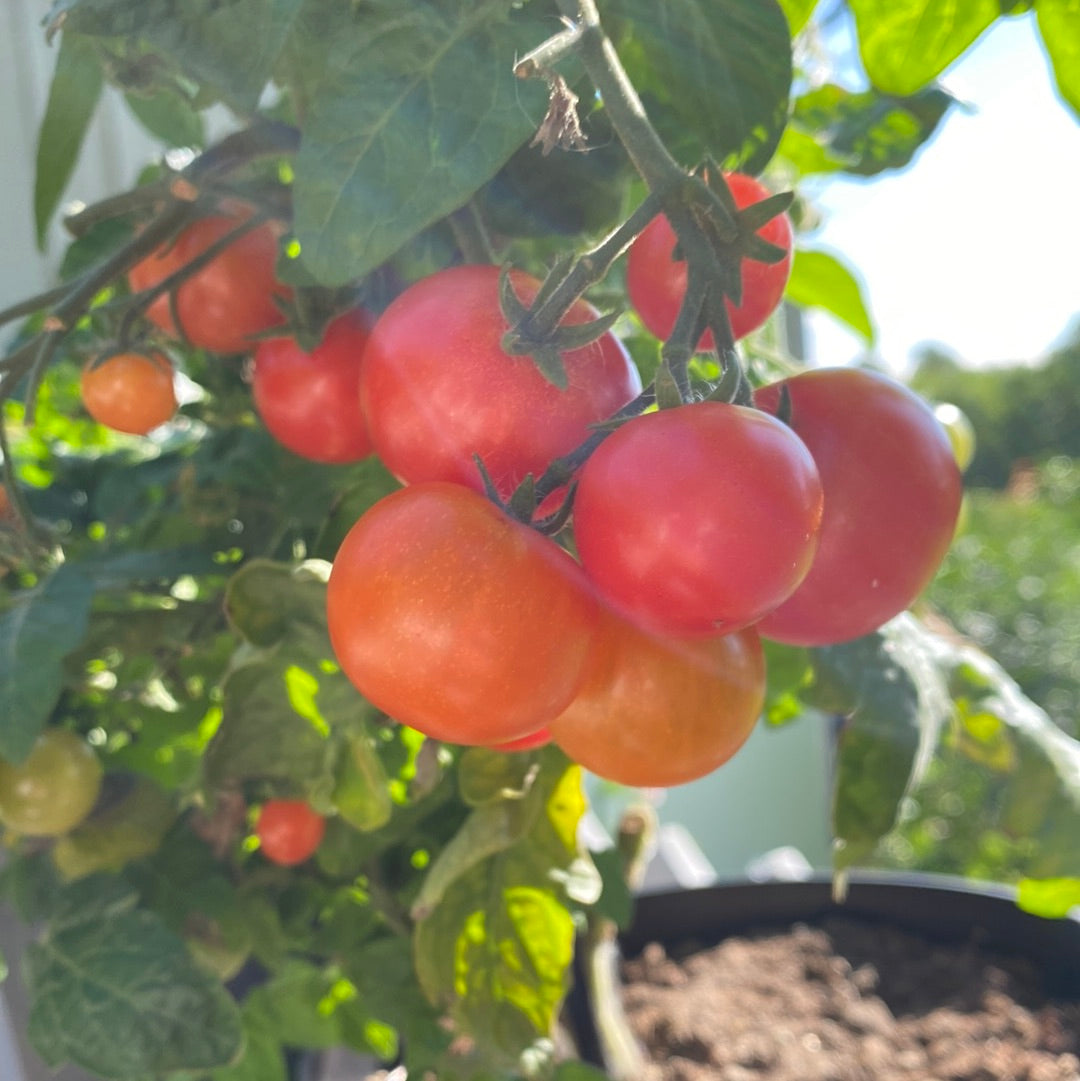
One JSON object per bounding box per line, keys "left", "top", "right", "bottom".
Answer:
{"left": 806, "top": 615, "right": 951, "bottom": 870}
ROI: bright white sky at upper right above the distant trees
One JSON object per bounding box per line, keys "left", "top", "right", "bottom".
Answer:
{"left": 805, "top": 16, "right": 1080, "bottom": 374}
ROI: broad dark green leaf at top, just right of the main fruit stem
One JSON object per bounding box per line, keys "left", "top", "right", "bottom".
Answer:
{"left": 601, "top": 0, "right": 791, "bottom": 173}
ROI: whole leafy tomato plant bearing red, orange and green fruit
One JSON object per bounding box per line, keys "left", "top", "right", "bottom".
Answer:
{"left": 0, "top": 0, "right": 1080, "bottom": 1081}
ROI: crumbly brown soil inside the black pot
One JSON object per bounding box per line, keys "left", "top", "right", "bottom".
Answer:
{"left": 624, "top": 919, "right": 1080, "bottom": 1081}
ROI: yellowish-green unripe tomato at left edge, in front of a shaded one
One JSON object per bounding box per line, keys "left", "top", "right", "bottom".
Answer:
{"left": 0, "top": 729, "right": 102, "bottom": 837}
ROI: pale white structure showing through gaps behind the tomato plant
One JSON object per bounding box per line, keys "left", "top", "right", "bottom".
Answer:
{"left": 0, "top": 8, "right": 829, "bottom": 1081}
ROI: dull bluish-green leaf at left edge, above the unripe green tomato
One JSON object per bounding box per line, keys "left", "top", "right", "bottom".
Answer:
{"left": 0, "top": 563, "right": 94, "bottom": 762}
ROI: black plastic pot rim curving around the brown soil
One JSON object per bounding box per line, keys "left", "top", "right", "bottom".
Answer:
{"left": 570, "top": 873, "right": 1080, "bottom": 1064}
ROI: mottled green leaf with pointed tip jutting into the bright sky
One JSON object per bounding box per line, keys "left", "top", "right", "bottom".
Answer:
{"left": 777, "top": 83, "right": 956, "bottom": 176}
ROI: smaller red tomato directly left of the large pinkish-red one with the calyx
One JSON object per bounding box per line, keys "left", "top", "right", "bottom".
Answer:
{"left": 252, "top": 311, "right": 371, "bottom": 463}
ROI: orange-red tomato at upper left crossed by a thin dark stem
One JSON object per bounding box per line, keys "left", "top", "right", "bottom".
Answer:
{"left": 128, "top": 214, "right": 289, "bottom": 352}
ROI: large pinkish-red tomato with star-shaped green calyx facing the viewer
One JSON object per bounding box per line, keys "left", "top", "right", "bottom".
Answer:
{"left": 360, "top": 266, "right": 641, "bottom": 497}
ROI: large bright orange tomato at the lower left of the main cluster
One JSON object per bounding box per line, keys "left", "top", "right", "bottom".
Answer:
{"left": 326, "top": 482, "right": 597, "bottom": 746}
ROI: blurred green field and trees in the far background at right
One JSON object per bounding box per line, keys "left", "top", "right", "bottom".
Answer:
{"left": 872, "top": 325, "right": 1080, "bottom": 881}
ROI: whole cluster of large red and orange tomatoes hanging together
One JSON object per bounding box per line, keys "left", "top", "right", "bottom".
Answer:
{"left": 78, "top": 176, "right": 961, "bottom": 808}
